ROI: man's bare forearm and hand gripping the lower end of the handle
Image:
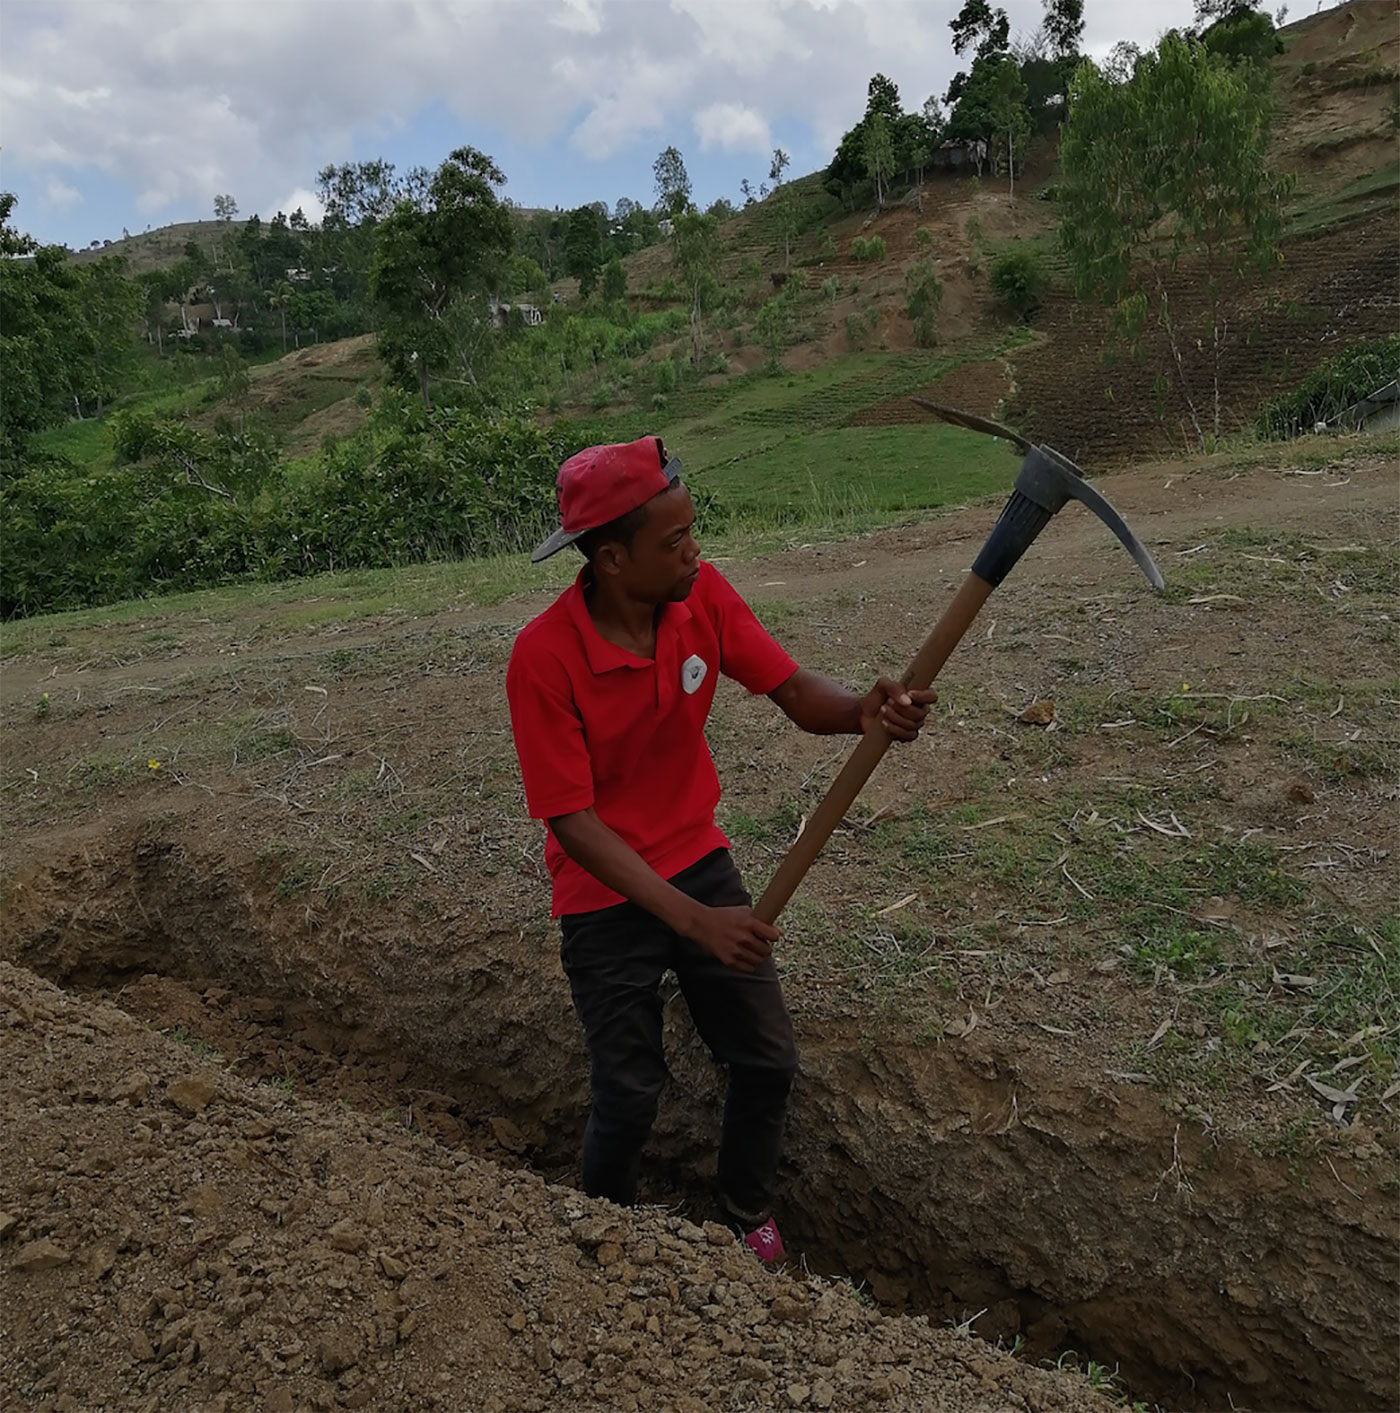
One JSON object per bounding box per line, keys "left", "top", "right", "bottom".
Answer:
{"left": 548, "top": 808, "right": 783, "bottom": 972}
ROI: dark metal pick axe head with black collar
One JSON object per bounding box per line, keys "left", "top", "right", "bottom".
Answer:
{"left": 913, "top": 397, "right": 1164, "bottom": 589}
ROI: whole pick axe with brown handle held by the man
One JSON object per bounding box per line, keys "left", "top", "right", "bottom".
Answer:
{"left": 754, "top": 397, "right": 1163, "bottom": 923}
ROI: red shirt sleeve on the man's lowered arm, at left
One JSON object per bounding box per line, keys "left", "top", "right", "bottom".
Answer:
{"left": 506, "top": 634, "right": 593, "bottom": 820}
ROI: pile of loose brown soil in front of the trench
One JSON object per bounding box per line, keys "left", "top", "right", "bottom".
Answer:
{"left": 0, "top": 964, "right": 1112, "bottom": 1413}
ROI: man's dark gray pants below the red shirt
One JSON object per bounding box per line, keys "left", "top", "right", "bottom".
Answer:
{"left": 559, "top": 849, "right": 797, "bottom": 1226}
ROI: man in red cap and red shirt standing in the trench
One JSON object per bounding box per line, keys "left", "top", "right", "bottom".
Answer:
{"left": 506, "top": 437, "right": 935, "bottom": 1262}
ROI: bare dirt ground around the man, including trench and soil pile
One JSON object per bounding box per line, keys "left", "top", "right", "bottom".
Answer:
{"left": 0, "top": 444, "right": 1400, "bottom": 1409}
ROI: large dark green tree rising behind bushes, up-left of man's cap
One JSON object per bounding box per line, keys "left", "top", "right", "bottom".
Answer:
{"left": 370, "top": 147, "right": 514, "bottom": 407}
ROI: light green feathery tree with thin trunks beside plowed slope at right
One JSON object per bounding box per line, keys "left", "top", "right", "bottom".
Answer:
{"left": 1060, "top": 34, "right": 1293, "bottom": 447}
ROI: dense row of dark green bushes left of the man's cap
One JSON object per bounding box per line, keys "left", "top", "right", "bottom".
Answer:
{"left": 0, "top": 394, "right": 583, "bottom": 617}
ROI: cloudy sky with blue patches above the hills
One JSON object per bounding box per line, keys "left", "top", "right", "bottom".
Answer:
{"left": 0, "top": 0, "right": 1194, "bottom": 246}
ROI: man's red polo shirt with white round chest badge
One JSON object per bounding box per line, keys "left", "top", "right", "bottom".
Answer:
{"left": 506, "top": 562, "right": 797, "bottom": 917}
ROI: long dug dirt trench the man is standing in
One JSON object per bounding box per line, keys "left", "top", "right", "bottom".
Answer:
{"left": 0, "top": 824, "right": 1400, "bottom": 1409}
